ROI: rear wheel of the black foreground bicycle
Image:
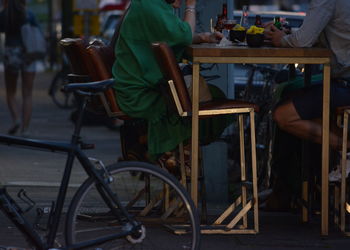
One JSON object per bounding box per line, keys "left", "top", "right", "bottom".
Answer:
{"left": 66, "top": 162, "right": 200, "bottom": 250}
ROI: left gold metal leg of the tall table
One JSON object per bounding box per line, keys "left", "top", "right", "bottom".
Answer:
{"left": 191, "top": 62, "right": 199, "bottom": 206}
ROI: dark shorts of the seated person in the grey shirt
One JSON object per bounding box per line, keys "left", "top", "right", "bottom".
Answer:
{"left": 292, "top": 82, "right": 350, "bottom": 120}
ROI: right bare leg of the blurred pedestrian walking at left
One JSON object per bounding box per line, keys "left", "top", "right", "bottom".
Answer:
{"left": 21, "top": 71, "right": 35, "bottom": 133}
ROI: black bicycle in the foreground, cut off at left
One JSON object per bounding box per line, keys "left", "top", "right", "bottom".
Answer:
{"left": 0, "top": 79, "right": 200, "bottom": 250}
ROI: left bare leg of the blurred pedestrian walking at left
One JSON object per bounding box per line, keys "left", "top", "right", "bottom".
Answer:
{"left": 5, "top": 68, "right": 19, "bottom": 134}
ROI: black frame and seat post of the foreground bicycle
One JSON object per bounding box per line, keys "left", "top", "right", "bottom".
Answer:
{"left": 0, "top": 93, "right": 139, "bottom": 250}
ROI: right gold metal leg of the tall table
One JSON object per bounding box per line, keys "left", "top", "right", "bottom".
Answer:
{"left": 321, "top": 64, "right": 330, "bottom": 236}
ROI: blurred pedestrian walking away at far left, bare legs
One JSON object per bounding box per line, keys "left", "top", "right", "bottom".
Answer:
{"left": 0, "top": 0, "right": 38, "bottom": 136}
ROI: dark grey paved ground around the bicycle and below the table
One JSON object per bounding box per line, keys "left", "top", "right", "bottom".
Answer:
{"left": 0, "top": 72, "right": 350, "bottom": 250}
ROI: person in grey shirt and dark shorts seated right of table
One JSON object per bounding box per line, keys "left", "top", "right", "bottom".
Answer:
{"left": 265, "top": 0, "right": 350, "bottom": 209}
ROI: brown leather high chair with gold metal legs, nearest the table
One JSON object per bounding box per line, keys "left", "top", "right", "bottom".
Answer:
{"left": 152, "top": 42, "right": 259, "bottom": 234}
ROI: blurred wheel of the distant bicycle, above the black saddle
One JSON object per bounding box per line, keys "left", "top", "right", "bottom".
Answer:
{"left": 49, "top": 71, "right": 76, "bottom": 109}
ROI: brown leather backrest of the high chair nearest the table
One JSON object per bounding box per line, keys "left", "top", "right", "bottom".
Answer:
{"left": 152, "top": 42, "right": 192, "bottom": 112}
